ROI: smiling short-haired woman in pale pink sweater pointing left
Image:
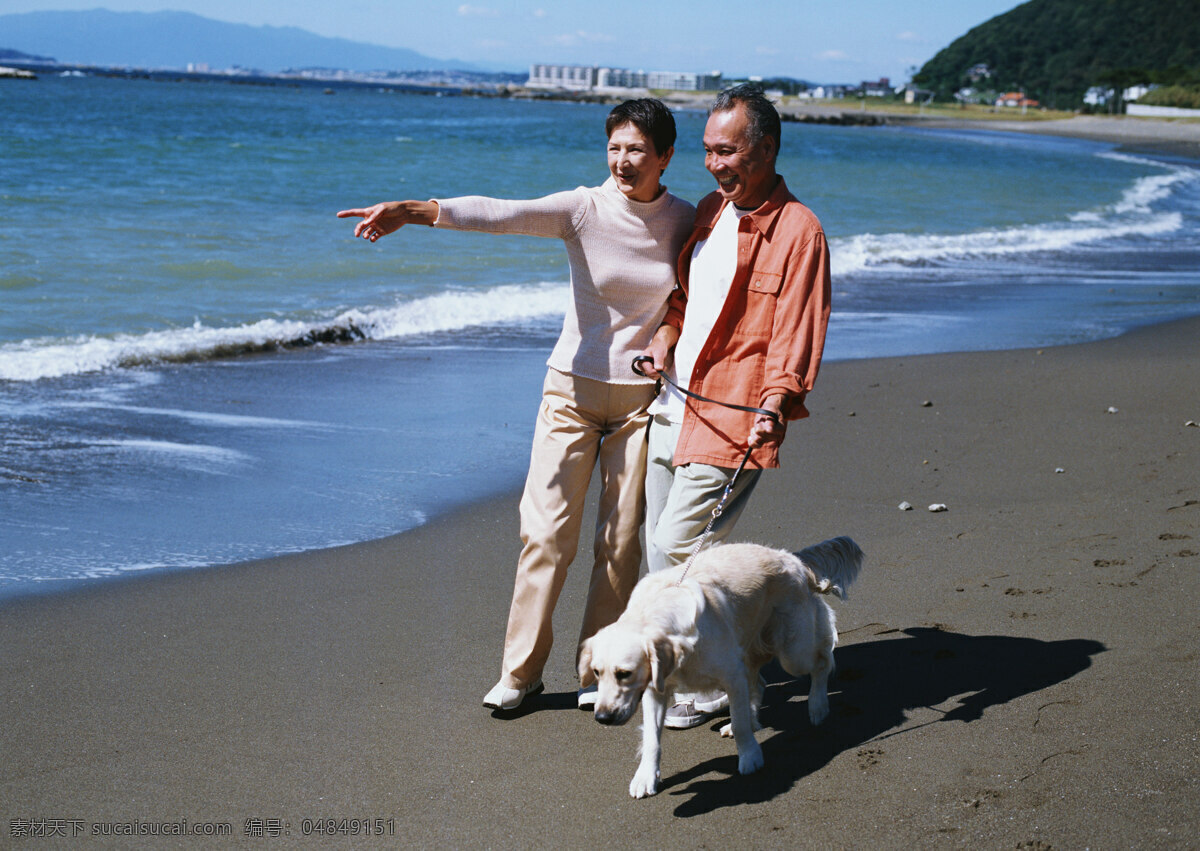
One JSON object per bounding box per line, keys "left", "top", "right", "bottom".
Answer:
{"left": 337, "top": 98, "right": 695, "bottom": 709}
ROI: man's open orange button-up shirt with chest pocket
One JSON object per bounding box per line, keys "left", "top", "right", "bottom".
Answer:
{"left": 662, "top": 178, "right": 829, "bottom": 467}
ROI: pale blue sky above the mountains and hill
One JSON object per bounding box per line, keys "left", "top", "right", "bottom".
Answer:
{"left": 0, "top": 0, "right": 1020, "bottom": 83}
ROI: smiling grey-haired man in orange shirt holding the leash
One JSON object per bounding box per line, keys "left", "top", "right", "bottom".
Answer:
{"left": 644, "top": 85, "right": 829, "bottom": 729}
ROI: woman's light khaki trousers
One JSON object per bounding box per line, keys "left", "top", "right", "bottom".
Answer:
{"left": 500, "top": 370, "right": 654, "bottom": 689}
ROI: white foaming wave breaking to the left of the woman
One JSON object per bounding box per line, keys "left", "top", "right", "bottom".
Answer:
{"left": 0, "top": 283, "right": 570, "bottom": 382}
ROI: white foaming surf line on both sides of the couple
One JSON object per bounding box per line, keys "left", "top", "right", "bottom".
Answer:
{"left": 0, "top": 152, "right": 1200, "bottom": 382}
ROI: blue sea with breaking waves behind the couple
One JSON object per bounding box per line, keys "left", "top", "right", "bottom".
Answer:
{"left": 0, "top": 77, "right": 1200, "bottom": 593}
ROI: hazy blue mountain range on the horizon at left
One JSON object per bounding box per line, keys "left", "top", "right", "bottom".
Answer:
{"left": 0, "top": 8, "right": 515, "bottom": 73}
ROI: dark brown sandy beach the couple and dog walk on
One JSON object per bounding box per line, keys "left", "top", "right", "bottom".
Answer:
{"left": 0, "top": 309, "right": 1200, "bottom": 849}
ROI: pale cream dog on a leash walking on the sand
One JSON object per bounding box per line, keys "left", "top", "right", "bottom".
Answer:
{"left": 580, "top": 538, "right": 863, "bottom": 798}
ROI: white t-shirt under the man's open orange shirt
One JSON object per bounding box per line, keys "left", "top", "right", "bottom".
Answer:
{"left": 650, "top": 204, "right": 754, "bottom": 422}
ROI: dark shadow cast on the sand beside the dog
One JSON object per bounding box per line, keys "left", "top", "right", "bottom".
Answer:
{"left": 661, "top": 628, "right": 1106, "bottom": 817}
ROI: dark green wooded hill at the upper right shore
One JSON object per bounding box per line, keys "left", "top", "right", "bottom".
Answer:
{"left": 913, "top": 0, "right": 1200, "bottom": 108}
